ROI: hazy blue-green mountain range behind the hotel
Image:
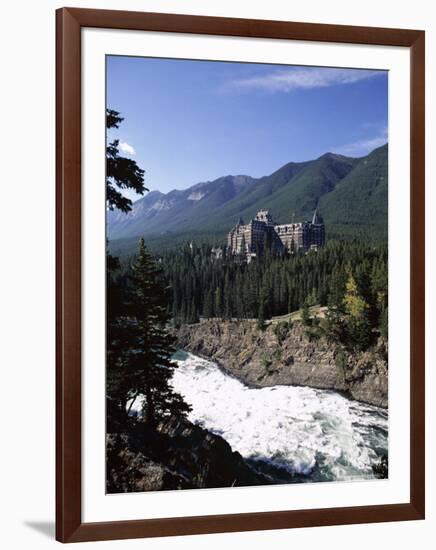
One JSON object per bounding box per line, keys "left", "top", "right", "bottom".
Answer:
{"left": 107, "top": 144, "right": 388, "bottom": 247}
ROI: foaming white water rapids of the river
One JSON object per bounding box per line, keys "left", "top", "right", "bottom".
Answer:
{"left": 169, "top": 352, "right": 388, "bottom": 481}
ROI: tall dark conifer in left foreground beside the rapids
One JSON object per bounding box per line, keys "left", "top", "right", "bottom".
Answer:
{"left": 107, "top": 239, "right": 190, "bottom": 425}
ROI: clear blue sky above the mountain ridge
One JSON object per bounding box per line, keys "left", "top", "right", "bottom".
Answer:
{"left": 107, "top": 56, "right": 388, "bottom": 199}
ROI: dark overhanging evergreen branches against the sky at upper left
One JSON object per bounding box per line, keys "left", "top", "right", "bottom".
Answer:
{"left": 106, "top": 109, "right": 148, "bottom": 212}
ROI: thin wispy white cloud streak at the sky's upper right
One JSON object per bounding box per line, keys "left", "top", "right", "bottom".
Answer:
{"left": 230, "top": 67, "right": 382, "bottom": 92}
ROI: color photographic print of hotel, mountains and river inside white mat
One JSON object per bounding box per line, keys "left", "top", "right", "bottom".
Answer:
{"left": 106, "top": 56, "right": 388, "bottom": 493}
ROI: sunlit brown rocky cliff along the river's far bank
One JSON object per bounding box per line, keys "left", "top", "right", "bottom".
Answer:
{"left": 177, "top": 320, "right": 388, "bottom": 407}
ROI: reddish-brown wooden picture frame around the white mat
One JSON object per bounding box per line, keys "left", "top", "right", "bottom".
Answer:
{"left": 56, "top": 8, "right": 425, "bottom": 542}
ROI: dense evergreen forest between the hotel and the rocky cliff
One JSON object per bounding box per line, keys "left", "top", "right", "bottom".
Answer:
{"left": 112, "top": 241, "right": 388, "bottom": 351}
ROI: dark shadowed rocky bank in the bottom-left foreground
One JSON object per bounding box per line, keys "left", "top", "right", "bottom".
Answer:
{"left": 106, "top": 417, "right": 271, "bottom": 493}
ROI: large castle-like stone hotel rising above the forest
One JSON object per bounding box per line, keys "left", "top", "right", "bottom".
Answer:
{"left": 227, "top": 210, "right": 325, "bottom": 261}
